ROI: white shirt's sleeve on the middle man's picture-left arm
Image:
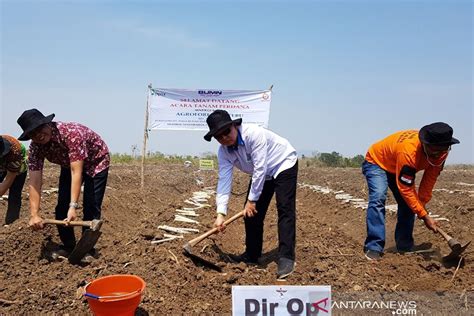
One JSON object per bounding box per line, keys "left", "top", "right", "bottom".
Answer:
{"left": 216, "top": 146, "right": 234, "bottom": 215}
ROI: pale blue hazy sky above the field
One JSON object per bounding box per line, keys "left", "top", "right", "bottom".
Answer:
{"left": 0, "top": 0, "right": 474, "bottom": 163}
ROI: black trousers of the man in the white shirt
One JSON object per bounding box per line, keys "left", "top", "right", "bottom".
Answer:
{"left": 244, "top": 162, "right": 298, "bottom": 261}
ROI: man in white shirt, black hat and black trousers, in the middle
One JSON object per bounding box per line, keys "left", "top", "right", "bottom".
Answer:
{"left": 204, "top": 110, "right": 298, "bottom": 278}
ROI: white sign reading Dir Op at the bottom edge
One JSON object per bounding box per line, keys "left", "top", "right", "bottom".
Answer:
{"left": 232, "top": 285, "right": 331, "bottom": 316}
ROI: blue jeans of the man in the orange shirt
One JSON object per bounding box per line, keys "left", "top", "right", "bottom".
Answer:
{"left": 362, "top": 161, "right": 415, "bottom": 252}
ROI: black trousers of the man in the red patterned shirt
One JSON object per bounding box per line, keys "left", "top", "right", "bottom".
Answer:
{"left": 55, "top": 167, "right": 109, "bottom": 250}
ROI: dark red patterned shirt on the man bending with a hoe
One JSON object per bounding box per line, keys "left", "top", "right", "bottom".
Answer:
{"left": 28, "top": 122, "right": 110, "bottom": 177}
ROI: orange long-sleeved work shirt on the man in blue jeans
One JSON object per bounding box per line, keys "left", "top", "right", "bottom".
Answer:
{"left": 365, "top": 130, "right": 448, "bottom": 218}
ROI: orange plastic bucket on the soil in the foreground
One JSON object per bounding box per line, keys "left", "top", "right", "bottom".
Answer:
{"left": 84, "top": 274, "right": 146, "bottom": 316}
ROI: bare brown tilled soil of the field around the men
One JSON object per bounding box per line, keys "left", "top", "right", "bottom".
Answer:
{"left": 0, "top": 164, "right": 474, "bottom": 315}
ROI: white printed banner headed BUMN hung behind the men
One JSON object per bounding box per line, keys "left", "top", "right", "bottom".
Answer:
{"left": 148, "top": 88, "right": 272, "bottom": 131}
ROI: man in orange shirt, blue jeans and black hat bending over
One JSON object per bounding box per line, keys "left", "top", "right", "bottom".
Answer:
{"left": 362, "top": 122, "right": 459, "bottom": 260}
